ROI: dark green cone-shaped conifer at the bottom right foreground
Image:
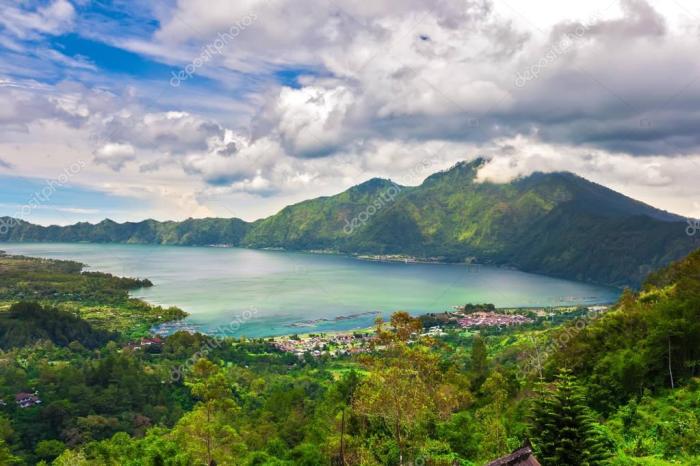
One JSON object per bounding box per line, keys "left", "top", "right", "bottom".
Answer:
{"left": 531, "top": 370, "right": 608, "bottom": 466}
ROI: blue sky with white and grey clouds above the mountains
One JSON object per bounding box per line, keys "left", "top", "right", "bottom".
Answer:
{"left": 0, "top": 0, "right": 700, "bottom": 223}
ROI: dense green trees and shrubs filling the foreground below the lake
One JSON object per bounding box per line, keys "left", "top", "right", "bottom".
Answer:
{"left": 0, "top": 244, "right": 700, "bottom": 466}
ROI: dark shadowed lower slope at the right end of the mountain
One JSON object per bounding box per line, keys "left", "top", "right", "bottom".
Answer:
{"left": 503, "top": 201, "right": 693, "bottom": 285}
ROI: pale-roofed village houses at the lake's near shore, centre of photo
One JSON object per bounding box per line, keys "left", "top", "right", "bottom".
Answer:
{"left": 274, "top": 333, "right": 371, "bottom": 358}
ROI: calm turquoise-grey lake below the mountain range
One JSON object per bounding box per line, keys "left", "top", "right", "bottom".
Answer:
{"left": 0, "top": 243, "right": 620, "bottom": 337}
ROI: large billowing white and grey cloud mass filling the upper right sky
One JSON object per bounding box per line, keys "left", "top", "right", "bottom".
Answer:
{"left": 126, "top": 0, "right": 700, "bottom": 158}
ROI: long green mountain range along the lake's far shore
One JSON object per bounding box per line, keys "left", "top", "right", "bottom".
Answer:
{"left": 1, "top": 159, "right": 693, "bottom": 285}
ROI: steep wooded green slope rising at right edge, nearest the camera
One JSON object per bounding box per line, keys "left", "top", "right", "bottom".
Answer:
{"left": 550, "top": 250, "right": 700, "bottom": 408}
